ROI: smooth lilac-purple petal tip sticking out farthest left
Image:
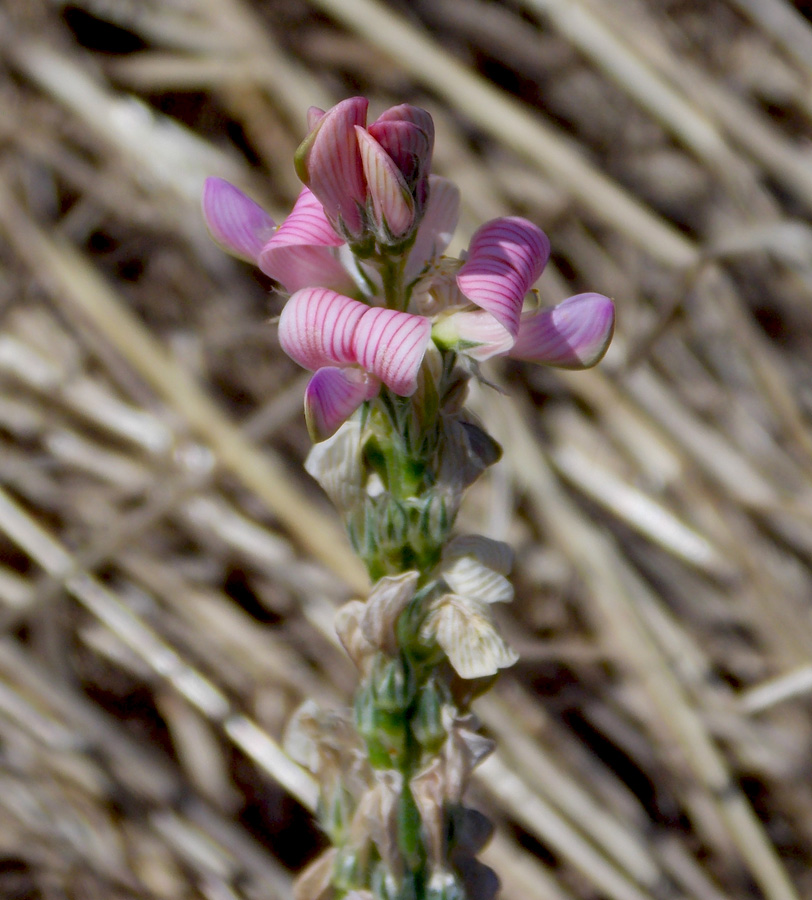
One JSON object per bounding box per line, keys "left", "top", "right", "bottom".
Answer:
{"left": 203, "top": 178, "right": 276, "bottom": 263}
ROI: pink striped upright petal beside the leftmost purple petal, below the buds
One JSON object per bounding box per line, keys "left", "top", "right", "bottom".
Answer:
{"left": 257, "top": 188, "right": 355, "bottom": 293}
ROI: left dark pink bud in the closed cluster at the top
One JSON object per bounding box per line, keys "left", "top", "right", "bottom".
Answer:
{"left": 294, "top": 97, "right": 369, "bottom": 237}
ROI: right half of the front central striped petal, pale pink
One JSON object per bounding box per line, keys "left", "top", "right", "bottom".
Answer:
{"left": 353, "top": 307, "right": 431, "bottom": 397}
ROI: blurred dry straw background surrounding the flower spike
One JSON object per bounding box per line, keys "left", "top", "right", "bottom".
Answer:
{"left": 0, "top": 0, "right": 812, "bottom": 900}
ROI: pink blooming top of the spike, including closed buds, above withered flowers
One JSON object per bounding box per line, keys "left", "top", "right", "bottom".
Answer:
{"left": 203, "top": 97, "right": 614, "bottom": 440}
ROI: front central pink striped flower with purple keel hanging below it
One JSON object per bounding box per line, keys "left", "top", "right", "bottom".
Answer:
{"left": 279, "top": 288, "right": 431, "bottom": 440}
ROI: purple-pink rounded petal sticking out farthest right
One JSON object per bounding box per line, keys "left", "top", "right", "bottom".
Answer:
{"left": 507, "top": 294, "right": 615, "bottom": 369}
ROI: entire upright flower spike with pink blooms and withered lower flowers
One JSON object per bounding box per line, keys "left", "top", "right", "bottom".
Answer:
{"left": 203, "top": 97, "right": 614, "bottom": 900}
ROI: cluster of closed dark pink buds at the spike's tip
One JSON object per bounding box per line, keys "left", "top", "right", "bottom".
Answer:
{"left": 296, "top": 97, "right": 434, "bottom": 246}
